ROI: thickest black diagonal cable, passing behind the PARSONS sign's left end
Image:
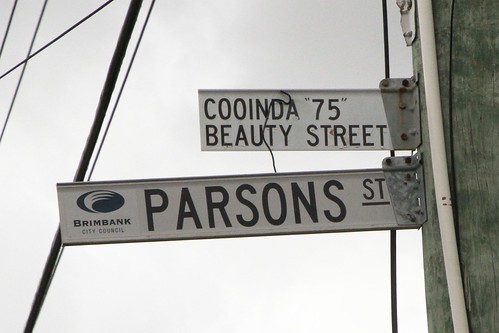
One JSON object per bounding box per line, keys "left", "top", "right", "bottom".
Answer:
{"left": 24, "top": 0, "right": 142, "bottom": 333}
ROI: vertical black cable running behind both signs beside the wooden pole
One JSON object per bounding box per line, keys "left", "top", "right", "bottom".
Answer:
{"left": 381, "top": 0, "right": 398, "bottom": 333}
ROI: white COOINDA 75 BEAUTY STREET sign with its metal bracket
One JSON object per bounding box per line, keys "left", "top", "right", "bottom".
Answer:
{"left": 199, "top": 79, "right": 420, "bottom": 151}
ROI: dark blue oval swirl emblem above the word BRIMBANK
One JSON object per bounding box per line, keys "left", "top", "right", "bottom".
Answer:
{"left": 76, "top": 190, "right": 125, "bottom": 213}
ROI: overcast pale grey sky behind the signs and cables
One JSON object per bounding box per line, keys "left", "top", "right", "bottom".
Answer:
{"left": 0, "top": 0, "right": 426, "bottom": 333}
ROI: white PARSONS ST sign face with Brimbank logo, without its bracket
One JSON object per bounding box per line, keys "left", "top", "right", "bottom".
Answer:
{"left": 57, "top": 170, "right": 419, "bottom": 245}
